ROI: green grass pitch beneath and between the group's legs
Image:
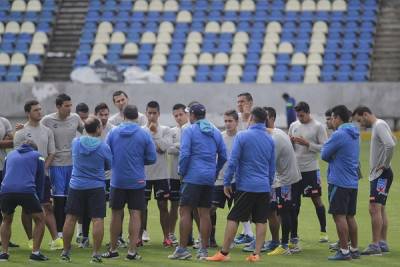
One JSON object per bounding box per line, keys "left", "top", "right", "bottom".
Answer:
{"left": 0, "top": 142, "right": 400, "bottom": 267}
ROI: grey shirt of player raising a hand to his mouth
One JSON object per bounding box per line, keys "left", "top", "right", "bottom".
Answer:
{"left": 143, "top": 125, "right": 172, "bottom": 180}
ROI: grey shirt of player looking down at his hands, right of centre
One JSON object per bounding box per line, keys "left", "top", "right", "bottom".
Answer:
{"left": 288, "top": 119, "right": 328, "bottom": 172}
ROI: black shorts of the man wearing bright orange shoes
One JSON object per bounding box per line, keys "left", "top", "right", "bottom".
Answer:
{"left": 228, "top": 191, "right": 270, "bottom": 223}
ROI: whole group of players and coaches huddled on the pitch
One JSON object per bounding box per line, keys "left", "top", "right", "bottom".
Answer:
{"left": 0, "top": 91, "right": 396, "bottom": 263}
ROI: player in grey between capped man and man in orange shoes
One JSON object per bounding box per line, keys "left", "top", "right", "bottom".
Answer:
{"left": 210, "top": 110, "right": 239, "bottom": 247}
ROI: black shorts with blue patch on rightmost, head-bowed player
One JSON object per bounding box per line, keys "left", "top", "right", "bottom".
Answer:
{"left": 369, "top": 168, "right": 393, "bottom": 206}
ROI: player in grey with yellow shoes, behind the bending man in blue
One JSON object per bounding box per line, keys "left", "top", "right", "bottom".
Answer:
{"left": 14, "top": 100, "right": 63, "bottom": 250}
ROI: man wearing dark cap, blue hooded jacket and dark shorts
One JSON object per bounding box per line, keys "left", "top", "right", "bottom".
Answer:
{"left": 168, "top": 104, "right": 226, "bottom": 260}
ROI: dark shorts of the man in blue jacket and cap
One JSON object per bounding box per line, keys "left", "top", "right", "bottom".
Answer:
{"left": 179, "top": 183, "right": 214, "bottom": 208}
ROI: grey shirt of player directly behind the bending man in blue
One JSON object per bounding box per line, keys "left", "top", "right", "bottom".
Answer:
{"left": 14, "top": 123, "right": 56, "bottom": 158}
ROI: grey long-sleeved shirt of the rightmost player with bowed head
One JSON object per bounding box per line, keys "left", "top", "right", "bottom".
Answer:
{"left": 369, "top": 119, "right": 396, "bottom": 181}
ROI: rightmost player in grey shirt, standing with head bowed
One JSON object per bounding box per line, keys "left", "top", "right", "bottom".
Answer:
{"left": 353, "top": 106, "right": 396, "bottom": 255}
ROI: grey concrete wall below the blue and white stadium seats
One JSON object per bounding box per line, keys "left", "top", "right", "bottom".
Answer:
{"left": 0, "top": 83, "right": 400, "bottom": 127}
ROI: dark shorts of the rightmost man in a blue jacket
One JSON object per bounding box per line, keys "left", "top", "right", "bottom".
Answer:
{"left": 328, "top": 184, "right": 358, "bottom": 216}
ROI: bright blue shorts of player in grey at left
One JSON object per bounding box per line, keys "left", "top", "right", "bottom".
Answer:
{"left": 49, "top": 166, "right": 72, "bottom": 197}
